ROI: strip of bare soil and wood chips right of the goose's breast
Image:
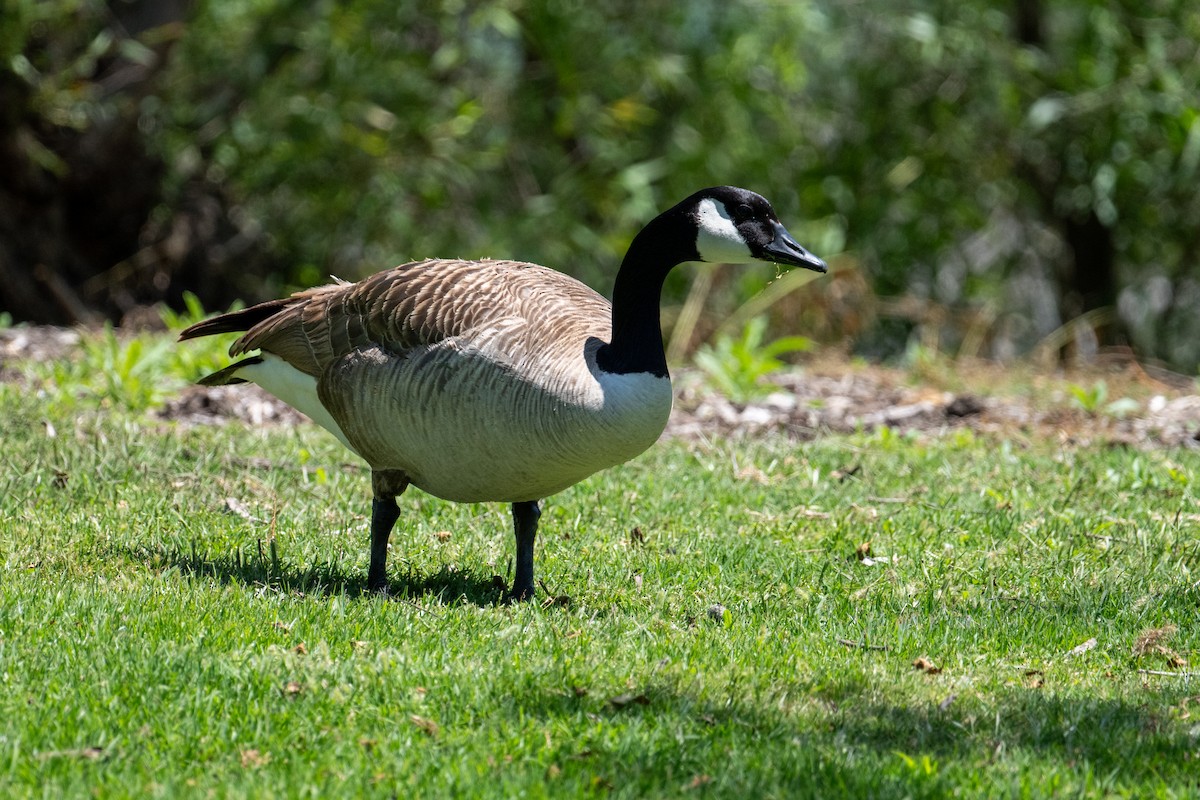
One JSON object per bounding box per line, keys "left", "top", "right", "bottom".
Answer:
{"left": 667, "top": 362, "right": 1200, "bottom": 447}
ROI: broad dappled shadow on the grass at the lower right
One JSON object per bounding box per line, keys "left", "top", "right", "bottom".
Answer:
{"left": 504, "top": 684, "right": 1200, "bottom": 798}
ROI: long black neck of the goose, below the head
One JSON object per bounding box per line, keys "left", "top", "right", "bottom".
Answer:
{"left": 596, "top": 204, "right": 700, "bottom": 378}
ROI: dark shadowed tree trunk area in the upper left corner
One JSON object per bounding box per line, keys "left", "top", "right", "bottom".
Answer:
{"left": 0, "top": 0, "right": 269, "bottom": 325}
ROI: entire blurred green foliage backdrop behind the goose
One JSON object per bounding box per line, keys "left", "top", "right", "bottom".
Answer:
{"left": 0, "top": 0, "right": 1200, "bottom": 371}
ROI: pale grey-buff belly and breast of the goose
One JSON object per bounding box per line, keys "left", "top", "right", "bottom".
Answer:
{"left": 323, "top": 354, "right": 671, "bottom": 503}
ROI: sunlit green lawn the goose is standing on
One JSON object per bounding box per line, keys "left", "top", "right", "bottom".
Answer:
{"left": 0, "top": 340, "right": 1200, "bottom": 798}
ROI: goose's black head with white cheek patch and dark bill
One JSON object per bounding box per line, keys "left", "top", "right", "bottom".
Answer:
{"left": 691, "top": 186, "right": 828, "bottom": 272}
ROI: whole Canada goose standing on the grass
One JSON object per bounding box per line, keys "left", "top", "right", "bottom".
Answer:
{"left": 180, "top": 186, "right": 826, "bottom": 600}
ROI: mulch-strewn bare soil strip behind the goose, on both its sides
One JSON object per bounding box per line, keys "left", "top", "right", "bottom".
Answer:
{"left": 0, "top": 326, "right": 1200, "bottom": 447}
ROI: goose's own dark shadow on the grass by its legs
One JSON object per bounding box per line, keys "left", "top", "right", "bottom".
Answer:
{"left": 111, "top": 546, "right": 502, "bottom": 606}
